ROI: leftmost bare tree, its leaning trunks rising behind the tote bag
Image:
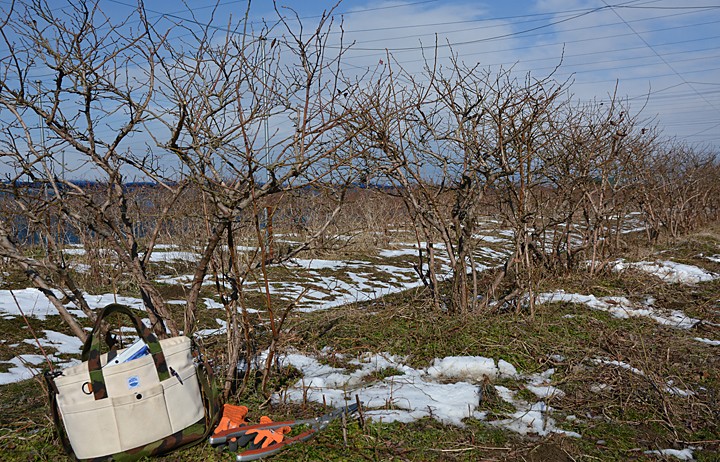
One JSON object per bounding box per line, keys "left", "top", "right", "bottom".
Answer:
{"left": 0, "top": 2, "right": 184, "bottom": 338}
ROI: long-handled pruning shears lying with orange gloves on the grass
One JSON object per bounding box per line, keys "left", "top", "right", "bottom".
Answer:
{"left": 210, "top": 404, "right": 358, "bottom": 462}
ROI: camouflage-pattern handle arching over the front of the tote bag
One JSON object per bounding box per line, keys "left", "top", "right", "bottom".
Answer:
{"left": 82, "top": 303, "right": 170, "bottom": 400}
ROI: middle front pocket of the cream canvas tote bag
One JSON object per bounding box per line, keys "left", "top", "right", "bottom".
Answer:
{"left": 110, "top": 385, "right": 173, "bottom": 451}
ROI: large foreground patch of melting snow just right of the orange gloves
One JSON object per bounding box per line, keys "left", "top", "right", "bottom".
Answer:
{"left": 274, "top": 353, "right": 579, "bottom": 436}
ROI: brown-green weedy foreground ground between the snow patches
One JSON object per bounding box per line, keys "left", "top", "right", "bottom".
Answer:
{"left": 0, "top": 230, "right": 720, "bottom": 462}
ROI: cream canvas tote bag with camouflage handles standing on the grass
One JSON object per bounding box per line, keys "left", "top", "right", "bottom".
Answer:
{"left": 48, "top": 304, "right": 215, "bottom": 460}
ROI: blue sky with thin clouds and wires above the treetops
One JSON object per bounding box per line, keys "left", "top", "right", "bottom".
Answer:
{"left": 81, "top": 0, "right": 720, "bottom": 147}
